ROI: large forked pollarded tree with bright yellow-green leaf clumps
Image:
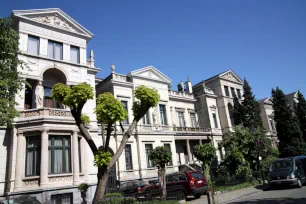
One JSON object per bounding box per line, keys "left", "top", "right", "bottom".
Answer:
{"left": 52, "top": 83, "right": 159, "bottom": 203}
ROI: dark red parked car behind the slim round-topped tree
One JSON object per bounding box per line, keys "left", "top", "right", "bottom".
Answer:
{"left": 141, "top": 171, "right": 208, "bottom": 199}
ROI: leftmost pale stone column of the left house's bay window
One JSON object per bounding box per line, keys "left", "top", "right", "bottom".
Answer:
{"left": 15, "top": 133, "right": 26, "bottom": 190}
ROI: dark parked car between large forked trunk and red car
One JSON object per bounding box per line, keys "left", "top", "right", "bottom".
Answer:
{"left": 116, "top": 180, "right": 148, "bottom": 197}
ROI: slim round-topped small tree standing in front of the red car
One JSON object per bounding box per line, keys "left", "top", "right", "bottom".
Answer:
{"left": 149, "top": 147, "right": 172, "bottom": 199}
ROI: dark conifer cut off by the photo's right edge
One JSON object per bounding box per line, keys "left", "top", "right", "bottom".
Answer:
{"left": 295, "top": 91, "right": 306, "bottom": 142}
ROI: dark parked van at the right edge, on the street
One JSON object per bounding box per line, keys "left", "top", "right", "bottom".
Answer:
{"left": 268, "top": 156, "right": 306, "bottom": 188}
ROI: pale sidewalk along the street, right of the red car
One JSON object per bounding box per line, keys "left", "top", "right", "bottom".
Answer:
{"left": 187, "top": 187, "right": 262, "bottom": 204}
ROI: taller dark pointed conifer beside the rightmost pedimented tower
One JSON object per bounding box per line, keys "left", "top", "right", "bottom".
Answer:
{"left": 242, "top": 79, "right": 262, "bottom": 130}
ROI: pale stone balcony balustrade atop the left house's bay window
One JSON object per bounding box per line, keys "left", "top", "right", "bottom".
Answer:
{"left": 18, "top": 108, "right": 74, "bottom": 122}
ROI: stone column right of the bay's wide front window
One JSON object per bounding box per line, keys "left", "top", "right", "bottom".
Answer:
{"left": 72, "top": 131, "right": 80, "bottom": 185}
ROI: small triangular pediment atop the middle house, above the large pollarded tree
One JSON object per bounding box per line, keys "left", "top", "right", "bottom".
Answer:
{"left": 130, "top": 66, "right": 171, "bottom": 84}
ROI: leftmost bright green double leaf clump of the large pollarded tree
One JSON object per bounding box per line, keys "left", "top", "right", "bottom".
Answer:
{"left": 52, "top": 83, "right": 94, "bottom": 109}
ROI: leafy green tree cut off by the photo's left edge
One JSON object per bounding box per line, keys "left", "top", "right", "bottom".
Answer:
{"left": 0, "top": 18, "right": 23, "bottom": 127}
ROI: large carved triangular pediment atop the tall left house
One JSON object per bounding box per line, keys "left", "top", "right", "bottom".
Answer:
{"left": 12, "top": 8, "right": 93, "bottom": 38}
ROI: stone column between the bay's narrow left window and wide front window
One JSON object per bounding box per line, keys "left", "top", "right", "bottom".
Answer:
{"left": 40, "top": 129, "right": 49, "bottom": 187}
